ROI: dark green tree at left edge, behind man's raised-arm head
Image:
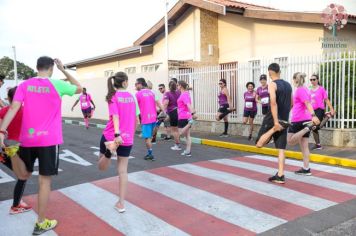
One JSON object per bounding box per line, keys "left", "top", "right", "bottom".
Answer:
{"left": 0, "top": 57, "right": 37, "bottom": 80}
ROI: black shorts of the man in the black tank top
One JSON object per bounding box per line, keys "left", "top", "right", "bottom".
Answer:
{"left": 256, "top": 113, "right": 287, "bottom": 149}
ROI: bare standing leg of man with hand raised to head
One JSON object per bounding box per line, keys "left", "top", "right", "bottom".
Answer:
{"left": 38, "top": 175, "right": 51, "bottom": 222}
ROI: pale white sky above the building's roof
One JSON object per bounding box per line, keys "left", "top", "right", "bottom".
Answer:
{"left": 0, "top": 0, "right": 356, "bottom": 72}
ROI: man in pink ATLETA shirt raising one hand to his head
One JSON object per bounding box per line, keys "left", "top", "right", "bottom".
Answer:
{"left": 0, "top": 57, "right": 82, "bottom": 235}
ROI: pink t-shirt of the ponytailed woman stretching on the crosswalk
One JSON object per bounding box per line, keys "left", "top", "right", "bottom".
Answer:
{"left": 103, "top": 90, "right": 140, "bottom": 146}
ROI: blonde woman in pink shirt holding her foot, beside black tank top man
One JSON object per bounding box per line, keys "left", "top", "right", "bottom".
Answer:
{"left": 287, "top": 72, "right": 320, "bottom": 175}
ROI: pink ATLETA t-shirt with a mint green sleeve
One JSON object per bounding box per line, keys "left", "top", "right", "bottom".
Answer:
{"left": 14, "top": 78, "right": 77, "bottom": 147}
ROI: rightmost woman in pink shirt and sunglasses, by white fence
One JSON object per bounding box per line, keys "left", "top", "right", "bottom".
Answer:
{"left": 310, "top": 75, "right": 335, "bottom": 150}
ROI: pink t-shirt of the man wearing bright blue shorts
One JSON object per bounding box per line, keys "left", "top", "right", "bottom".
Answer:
{"left": 136, "top": 89, "right": 157, "bottom": 125}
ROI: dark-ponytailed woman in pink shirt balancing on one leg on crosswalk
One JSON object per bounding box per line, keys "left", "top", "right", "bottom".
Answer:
{"left": 98, "top": 72, "right": 140, "bottom": 213}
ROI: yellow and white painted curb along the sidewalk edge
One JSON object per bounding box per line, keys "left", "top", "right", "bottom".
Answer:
{"left": 63, "top": 119, "right": 356, "bottom": 168}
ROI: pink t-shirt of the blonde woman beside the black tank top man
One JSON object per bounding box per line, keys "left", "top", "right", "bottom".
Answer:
{"left": 291, "top": 86, "right": 312, "bottom": 122}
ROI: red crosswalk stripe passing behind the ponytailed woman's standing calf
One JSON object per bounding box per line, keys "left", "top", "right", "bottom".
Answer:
{"left": 95, "top": 174, "right": 255, "bottom": 236}
